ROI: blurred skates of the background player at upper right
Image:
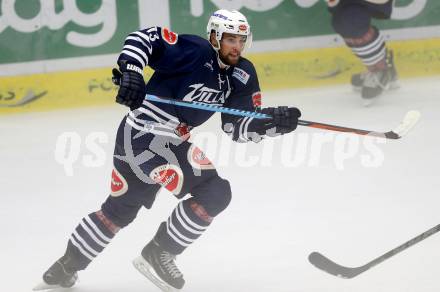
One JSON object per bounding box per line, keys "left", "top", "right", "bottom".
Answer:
{"left": 351, "top": 51, "right": 399, "bottom": 105}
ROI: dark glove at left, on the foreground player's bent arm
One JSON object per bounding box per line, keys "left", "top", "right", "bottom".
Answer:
{"left": 112, "top": 62, "right": 146, "bottom": 110}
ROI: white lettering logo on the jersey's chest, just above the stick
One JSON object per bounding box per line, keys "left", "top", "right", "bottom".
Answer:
{"left": 183, "top": 83, "right": 231, "bottom": 105}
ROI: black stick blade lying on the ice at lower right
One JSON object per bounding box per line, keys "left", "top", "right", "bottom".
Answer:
{"left": 309, "top": 252, "right": 368, "bottom": 279}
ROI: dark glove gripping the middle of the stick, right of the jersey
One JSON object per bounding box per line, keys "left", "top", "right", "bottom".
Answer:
{"left": 261, "top": 106, "right": 301, "bottom": 134}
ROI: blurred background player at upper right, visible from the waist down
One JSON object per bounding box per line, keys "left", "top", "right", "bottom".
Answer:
{"left": 327, "top": 0, "right": 397, "bottom": 104}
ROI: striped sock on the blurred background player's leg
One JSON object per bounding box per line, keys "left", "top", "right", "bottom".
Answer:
{"left": 344, "top": 27, "right": 386, "bottom": 71}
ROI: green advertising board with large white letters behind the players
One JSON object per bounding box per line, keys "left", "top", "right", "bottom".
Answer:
{"left": 0, "top": 0, "right": 440, "bottom": 68}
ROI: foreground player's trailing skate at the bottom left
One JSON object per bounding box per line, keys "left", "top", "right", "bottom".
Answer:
{"left": 33, "top": 256, "right": 78, "bottom": 291}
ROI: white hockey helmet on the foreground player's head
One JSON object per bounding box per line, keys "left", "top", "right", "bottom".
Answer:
{"left": 206, "top": 9, "right": 252, "bottom": 50}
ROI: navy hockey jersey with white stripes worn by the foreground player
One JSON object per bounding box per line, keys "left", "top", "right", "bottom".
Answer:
{"left": 118, "top": 27, "right": 262, "bottom": 142}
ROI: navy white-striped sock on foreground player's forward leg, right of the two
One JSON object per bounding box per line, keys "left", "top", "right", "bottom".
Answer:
{"left": 154, "top": 199, "right": 213, "bottom": 255}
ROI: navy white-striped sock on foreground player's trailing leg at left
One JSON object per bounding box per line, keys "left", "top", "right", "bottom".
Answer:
{"left": 65, "top": 211, "right": 120, "bottom": 271}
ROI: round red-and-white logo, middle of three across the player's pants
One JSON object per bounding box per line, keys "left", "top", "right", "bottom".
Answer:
{"left": 150, "top": 164, "right": 183, "bottom": 195}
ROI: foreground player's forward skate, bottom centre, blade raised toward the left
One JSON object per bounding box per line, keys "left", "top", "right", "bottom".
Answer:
{"left": 133, "top": 240, "right": 185, "bottom": 292}
